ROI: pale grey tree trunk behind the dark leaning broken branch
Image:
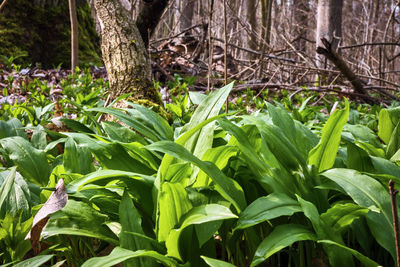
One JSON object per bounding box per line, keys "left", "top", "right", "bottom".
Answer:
{"left": 316, "top": 0, "right": 343, "bottom": 68}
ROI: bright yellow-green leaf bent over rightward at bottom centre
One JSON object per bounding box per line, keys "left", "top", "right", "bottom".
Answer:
{"left": 165, "top": 204, "right": 237, "bottom": 260}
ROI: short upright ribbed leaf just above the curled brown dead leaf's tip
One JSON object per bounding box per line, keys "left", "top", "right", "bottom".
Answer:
{"left": 63, "top": 137, "right": 95, "bottom": 174}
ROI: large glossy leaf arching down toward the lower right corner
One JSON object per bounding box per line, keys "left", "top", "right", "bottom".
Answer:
{"left": 323, "top": 169, "right": 396, "bottom": 259}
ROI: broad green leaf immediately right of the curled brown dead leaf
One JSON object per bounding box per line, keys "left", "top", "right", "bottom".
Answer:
{"left": 42, "top": 200, "right": 119, "bottom": 245}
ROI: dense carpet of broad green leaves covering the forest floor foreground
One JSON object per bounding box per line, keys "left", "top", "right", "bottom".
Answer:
{"left": 0, "top": 79, "right": 400, "bottom": 266}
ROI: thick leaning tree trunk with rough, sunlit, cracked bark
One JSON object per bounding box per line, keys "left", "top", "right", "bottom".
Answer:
{"left": 94, "top": 0, "right": 161, "bottom": 104}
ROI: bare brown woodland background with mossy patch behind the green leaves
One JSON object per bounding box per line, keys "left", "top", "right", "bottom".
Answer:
{"left": 0, "top": 0, "right": 400, "bottom": 103}
